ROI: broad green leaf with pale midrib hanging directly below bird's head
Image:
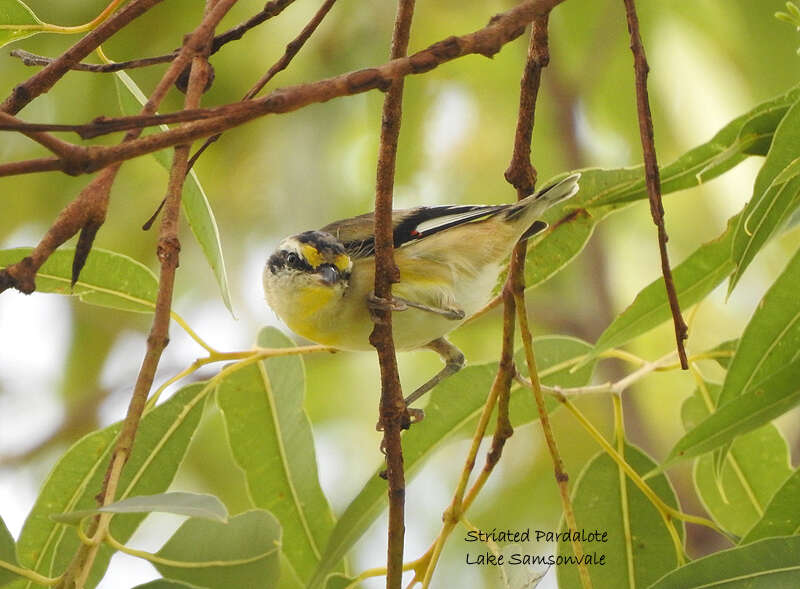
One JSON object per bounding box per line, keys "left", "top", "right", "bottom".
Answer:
{"left": 217, "top": 327, "right": 334, "bottom": 582}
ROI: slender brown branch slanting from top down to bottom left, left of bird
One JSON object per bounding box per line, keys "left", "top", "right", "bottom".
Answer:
{"left": 57, "top": 0, "right": 225, "bottom": 589}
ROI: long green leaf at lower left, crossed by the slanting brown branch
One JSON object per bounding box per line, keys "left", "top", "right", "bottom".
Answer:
{"left": 17, "top": 384, "right": 208, "bottom": 588}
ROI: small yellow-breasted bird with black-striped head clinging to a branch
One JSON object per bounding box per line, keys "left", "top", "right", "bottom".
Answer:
{"left": 263, "top": 173, "right": 580, "bottom": 420}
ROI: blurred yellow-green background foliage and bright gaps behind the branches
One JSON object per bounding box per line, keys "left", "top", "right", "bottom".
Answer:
{"left": 0, "top": 0, "right": 800, "bottom": 588}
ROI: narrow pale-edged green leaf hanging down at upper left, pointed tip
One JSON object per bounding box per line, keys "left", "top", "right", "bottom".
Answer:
{"left": 114, "top": 72, "right": 233, "bottom": 314}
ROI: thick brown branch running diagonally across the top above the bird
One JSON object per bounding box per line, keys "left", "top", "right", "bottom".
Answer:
{"left": 0, "top": 0, "right": 563, "bottom": 176}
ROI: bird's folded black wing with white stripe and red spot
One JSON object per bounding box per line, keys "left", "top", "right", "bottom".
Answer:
{"left": 320, "top": 205, "right": 509, "bottom": 259}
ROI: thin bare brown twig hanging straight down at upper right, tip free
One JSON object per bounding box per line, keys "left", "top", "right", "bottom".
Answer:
{"left": 623, "top": 0, "right": 689, "bottom": 370}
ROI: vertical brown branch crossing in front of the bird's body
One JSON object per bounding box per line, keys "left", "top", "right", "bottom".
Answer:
{"left": 369, "top": 0, "right": 414, "bottom": 589}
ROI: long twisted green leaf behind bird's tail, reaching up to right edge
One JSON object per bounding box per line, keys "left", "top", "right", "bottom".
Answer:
{"left": 520, "top": 87, "right": 800, "bottom": 287}
